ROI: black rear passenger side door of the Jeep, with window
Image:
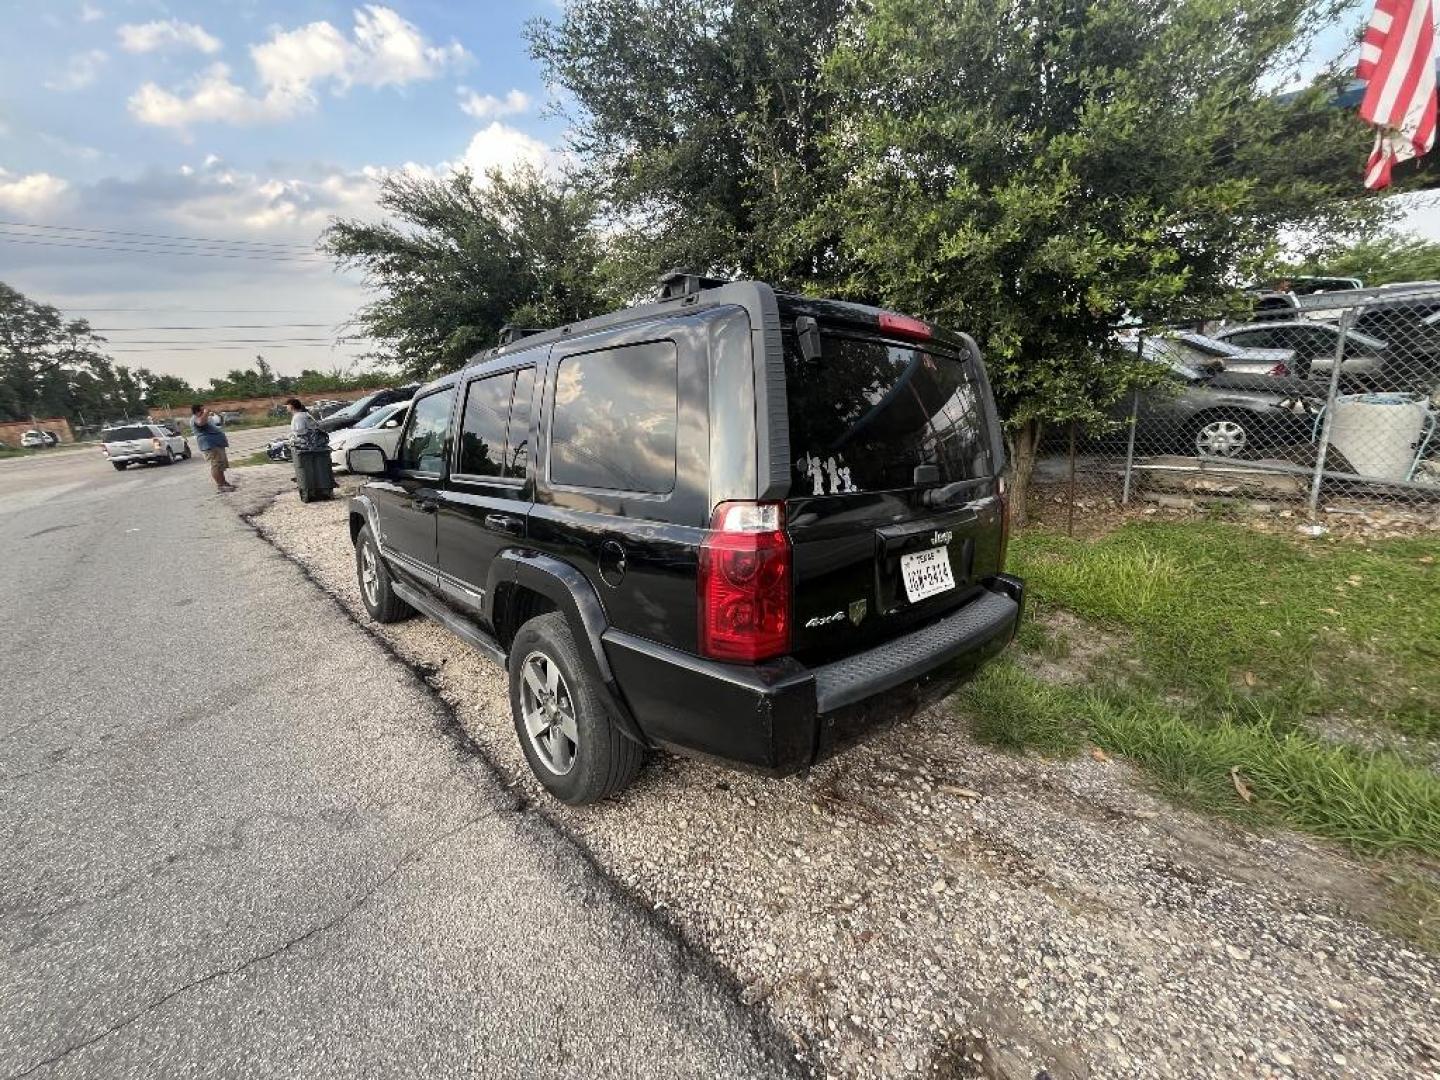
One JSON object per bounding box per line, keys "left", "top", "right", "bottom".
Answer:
{"left": 436, "top": 360, "right": 549, "bottom": 613}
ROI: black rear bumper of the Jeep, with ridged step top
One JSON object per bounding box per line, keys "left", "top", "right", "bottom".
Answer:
{"left": 602, "top": 575, "right": 1025, "bottom": 776}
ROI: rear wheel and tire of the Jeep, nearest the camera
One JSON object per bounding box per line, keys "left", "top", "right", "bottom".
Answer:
{"left": 508, "top": 612, "right": 645, "bottom": 806}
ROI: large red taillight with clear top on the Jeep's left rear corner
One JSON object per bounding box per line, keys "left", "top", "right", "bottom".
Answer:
{"left": 697, "top": 503, "right": 791, "bottom": 664}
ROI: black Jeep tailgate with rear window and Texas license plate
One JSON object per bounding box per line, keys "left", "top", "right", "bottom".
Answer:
{"left": 785, "top": 321, "right": 1002, "bottom": 660}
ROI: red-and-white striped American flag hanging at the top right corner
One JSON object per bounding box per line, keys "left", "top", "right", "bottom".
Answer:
{"left": 1355, "top": 0, "right": 1436, "bottom": 189}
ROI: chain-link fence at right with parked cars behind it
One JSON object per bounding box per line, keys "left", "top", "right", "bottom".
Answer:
{"left": 1032, "top": 282, "right": 1440, "bottom": 529}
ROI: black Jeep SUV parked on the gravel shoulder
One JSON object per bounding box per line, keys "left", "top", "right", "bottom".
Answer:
{"left": 348, "top": 274, "right": 1024, "bottom": 804}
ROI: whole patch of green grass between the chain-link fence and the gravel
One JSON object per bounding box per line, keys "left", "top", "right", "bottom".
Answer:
{"left": 956, "top": 521, "right": 1440, "bottom": 869}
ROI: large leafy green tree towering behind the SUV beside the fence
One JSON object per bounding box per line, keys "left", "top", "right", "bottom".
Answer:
{"left": 531, "top": 0, "right": 1381, "bottom": 518}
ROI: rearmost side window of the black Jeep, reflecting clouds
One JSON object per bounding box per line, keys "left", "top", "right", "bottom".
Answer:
{"left": 550, "top": 341, "right": 678, "bottom": 494}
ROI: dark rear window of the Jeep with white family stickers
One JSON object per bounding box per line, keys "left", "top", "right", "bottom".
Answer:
{"left": 785, "top": 333, "right": 995, "bottom": 495}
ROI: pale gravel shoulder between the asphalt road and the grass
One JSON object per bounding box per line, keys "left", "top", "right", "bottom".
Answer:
{"left": 236, "top": 469, "right": 1440, "bottom": 1077}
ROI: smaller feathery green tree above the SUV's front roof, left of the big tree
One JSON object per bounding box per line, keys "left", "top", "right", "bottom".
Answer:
{"left": 321, "top": 168, "right": 615, "bottom": 376}
